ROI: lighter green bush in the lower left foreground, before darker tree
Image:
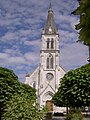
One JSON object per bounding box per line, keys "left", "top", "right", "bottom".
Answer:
{"left": 4, "top": 94, "right": 45, "bottom": 120}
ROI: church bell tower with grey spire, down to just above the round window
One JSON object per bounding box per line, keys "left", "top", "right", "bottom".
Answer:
{"left": 40, "top": 4, "right": 59, "bottom": 72}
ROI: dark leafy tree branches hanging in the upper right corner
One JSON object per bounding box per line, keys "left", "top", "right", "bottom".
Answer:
{"left": 72, "top": 0, "right": 90, "bottom": 63}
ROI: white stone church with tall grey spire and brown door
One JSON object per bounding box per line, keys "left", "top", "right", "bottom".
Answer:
{"left": 25, "top": 3, "right": 65, "bottom": 111}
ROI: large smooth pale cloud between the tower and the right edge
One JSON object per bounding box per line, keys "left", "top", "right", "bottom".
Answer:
{"left": 60, "top": 43, "right": 88, "bottom": 71}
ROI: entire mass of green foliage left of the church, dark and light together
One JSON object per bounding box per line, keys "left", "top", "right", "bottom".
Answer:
{"left": 0, "top": 67, "right": 46, "bottom": 120}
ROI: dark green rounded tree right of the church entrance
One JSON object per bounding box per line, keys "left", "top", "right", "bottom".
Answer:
{"left": 53, "top": 64, "right": 90, "bottom": 107}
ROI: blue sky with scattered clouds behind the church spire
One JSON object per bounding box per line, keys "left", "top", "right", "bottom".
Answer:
{"left": 0, "top": 0, "right": 88, "bottom": 82}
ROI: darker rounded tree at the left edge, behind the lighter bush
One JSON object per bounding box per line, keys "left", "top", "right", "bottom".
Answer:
{"left": 0, "top": 67, "right": 20, "bottom": 117}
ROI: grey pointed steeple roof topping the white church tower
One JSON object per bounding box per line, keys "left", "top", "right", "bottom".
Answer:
{"left": 43, "top": 1, "right": 58, "bottom": 35}
